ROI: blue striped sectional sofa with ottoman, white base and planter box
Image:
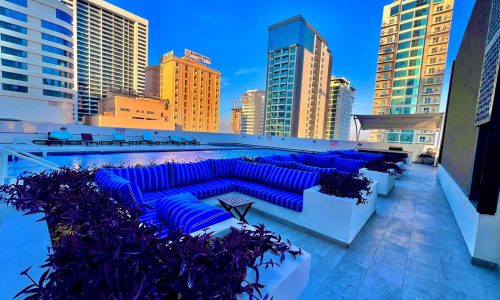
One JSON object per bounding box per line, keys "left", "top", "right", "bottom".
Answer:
{"left": 96, "top": 157, "right": 377, "bottom": 245}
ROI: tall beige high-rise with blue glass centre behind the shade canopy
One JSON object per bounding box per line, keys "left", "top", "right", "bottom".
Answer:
{"left": 370, "top": 0, "right": 454, "bottom": 144}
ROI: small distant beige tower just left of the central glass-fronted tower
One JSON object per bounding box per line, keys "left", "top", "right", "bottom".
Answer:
{"left": 241, "top": 90, "right": 266, "bottom": 134}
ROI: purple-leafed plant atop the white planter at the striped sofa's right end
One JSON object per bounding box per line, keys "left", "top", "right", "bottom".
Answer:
{"left": 319, "top": 173, "right": 372, "bottom": 205}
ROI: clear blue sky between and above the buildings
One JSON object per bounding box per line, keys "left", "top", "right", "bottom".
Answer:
{"left": 108, "top": 0, "right": 474, "bottom": 132}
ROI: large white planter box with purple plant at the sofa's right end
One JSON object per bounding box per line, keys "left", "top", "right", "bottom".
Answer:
{"left": 304, "top": 173, "right": 378, "bottom": 246}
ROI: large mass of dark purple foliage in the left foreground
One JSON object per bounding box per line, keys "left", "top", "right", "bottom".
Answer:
{"left": 0, "top": 168, "right": 301, "bottom": 299}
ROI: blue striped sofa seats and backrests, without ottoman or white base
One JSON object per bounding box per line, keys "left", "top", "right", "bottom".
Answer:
{"left": 96, "top": 159, "right": 319, "bottom": 229}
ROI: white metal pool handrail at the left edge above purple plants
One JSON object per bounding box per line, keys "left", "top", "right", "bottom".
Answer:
{"left": 0, "top": 137, "right": 59, "bottom": 184}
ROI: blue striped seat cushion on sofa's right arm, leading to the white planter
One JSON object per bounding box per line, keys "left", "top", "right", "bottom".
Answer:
{"left": 224, "top": 178, "right": 303, "bottom": 212}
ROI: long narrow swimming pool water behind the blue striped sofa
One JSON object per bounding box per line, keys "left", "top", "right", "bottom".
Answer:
{"left": 8, "top": 148, "right": 290, "bottom": 177}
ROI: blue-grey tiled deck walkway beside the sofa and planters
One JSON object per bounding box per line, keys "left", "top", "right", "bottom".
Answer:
{"left": 248, "top": 164, "right": 500, "bottom": 300}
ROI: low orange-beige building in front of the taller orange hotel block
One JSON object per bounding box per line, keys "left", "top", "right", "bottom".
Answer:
{"left": 83, "top": 91, "right": 175, "bottom": 130}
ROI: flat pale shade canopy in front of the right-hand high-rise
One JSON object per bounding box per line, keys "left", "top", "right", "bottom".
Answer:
{"left": 353, "top": 113, "right": 444, "bottom": 130}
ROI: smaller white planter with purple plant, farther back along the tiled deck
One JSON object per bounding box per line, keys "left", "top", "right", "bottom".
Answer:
{"left": 359, "top": 160, "right": 403, "bottom": 196}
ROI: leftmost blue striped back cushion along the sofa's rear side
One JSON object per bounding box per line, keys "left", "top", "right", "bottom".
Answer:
{"left": 108, "top": 164, "right": 170, "bottom": 192}
